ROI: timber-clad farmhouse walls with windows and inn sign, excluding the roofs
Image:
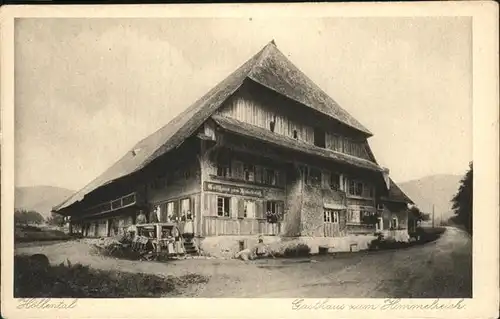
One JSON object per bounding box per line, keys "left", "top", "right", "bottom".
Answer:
{"left": 65, "top": 55, "right": 410, "bottom": 238}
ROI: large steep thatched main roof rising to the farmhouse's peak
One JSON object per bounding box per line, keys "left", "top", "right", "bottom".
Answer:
{"left": 53, "top": 41, "right": 372, "bottom": 211}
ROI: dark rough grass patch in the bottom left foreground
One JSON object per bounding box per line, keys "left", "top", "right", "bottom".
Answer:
{"left": 14, "top": 255, "right": 208, "bottom": 298}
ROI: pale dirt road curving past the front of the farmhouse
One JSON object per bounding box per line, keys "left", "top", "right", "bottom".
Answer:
{"left": 16, "top": 228, "right": 472, "bottom": 298}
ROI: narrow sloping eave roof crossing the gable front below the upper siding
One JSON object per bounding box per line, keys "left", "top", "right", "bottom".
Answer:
{"left": 212, "top": 115, "right": 382, "bottom": 171}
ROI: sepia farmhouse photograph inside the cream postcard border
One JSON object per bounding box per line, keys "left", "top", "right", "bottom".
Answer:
{"left": 2, "top": 4, "right": 498, "bottom": 319}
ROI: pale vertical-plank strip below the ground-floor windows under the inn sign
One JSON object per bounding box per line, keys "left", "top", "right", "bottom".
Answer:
{"left": 202, "top": 216, "right": 282, "bottom": 236}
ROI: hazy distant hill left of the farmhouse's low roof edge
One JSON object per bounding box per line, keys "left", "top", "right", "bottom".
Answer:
{"left": 14, "top": 186, "right": 74, "bottom": 217}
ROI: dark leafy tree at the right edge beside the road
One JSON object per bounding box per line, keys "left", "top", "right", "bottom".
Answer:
{"left": 451, "top": 162, "right": 473, "bottom": 234}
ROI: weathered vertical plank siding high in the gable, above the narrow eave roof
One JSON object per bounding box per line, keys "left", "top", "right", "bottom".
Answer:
{"left": 217, "top": 90, "right": 372, "bottom": 160}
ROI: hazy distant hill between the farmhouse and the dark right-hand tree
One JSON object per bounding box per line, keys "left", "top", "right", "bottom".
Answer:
{"left": 398, "top": 174, "right": 462, "bottom": 223}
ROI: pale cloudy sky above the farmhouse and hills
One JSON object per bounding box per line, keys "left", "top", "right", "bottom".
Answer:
{"left": 14, "top": 17, "right": 472, "bottom": 190}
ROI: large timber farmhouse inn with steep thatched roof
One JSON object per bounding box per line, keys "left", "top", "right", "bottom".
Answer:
{"left": 54, "top": 41, "right": 412, "bottom": 255}
